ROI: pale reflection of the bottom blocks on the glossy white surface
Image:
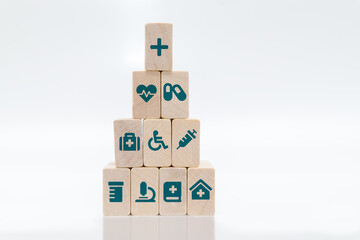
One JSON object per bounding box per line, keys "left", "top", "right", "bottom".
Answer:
{"left": 103, "top": 216, "right": 215, "bottom": 240}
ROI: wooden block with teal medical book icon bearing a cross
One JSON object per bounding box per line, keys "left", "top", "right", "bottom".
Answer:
{"left": 159, "top": 167, "right": 187, "bottom": 216}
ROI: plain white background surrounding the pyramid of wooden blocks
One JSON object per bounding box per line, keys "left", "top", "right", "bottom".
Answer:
{"left": 0, "top": 0, "right": 360, "bottom": 240}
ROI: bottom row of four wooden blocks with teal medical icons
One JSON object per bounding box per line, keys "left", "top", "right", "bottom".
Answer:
{"left": 103, "top": 161, "right": 215, "bottom": 216}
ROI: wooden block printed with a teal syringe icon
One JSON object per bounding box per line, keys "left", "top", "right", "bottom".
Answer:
{"left": 172, "top": 119, "right": 200, "bottom": 167}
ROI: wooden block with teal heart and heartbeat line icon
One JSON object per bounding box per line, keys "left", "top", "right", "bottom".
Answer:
{"left": 133, "top": 71, "right": 160, "bottom": 118}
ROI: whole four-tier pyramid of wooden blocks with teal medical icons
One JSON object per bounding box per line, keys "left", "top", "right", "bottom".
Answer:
{"left": 103, "top": 23, "right": 215, "bottom": 216}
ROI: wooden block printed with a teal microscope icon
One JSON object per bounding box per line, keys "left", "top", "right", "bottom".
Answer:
{"left": 131, "top": 167, "right": 159, "bottom": 216}
